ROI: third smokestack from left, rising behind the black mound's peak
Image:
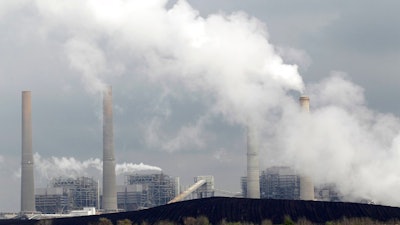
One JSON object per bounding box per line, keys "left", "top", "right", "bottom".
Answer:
{"left": 247, "top": 126, "right": 260, "bottom": 198}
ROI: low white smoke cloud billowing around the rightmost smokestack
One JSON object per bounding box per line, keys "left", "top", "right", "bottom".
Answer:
{"left": 267, "top": 73, "right": 400, "bottom": 205}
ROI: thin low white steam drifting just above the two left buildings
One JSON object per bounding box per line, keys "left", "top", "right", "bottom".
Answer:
{"left": 34, "top": 153, "right": 161, "bottom": 185}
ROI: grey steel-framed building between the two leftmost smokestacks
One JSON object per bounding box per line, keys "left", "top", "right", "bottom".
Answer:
{"left": 35, "top": 177, "right": 99, "bottom": 214}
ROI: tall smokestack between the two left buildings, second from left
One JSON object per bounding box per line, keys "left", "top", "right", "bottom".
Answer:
{"left": 103, "top": 86, "right": 117, "bottom": 212}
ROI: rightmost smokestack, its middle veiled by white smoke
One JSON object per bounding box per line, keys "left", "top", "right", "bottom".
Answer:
{"left": 299, "top": 96, "right": 314, "bottom": 200}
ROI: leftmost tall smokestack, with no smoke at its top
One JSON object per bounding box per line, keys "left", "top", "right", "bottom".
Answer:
{"left": 21, "top": 91, "right": 36, "bottom": 213}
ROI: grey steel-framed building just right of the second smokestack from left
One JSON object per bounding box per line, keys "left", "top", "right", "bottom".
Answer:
{"left": 117, "top": 173, "right": 179, "bottom": 210}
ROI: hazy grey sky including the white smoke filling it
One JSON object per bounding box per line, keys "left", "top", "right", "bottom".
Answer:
{"left": 0, "top": 0, "right": 400, "bottom": 211}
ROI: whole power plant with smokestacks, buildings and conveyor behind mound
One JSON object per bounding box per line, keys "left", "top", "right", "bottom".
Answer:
{"left": 16, "top": 89, "right": 322, "bottom": 214}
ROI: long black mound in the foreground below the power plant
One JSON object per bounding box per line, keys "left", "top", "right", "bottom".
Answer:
{"left": 0, "top": 197, "right": 400, "bottom": 225}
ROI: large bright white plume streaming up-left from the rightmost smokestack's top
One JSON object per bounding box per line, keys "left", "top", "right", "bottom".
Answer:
{"left": 32, "top": 0, "right": 304, "bottom": 124}
